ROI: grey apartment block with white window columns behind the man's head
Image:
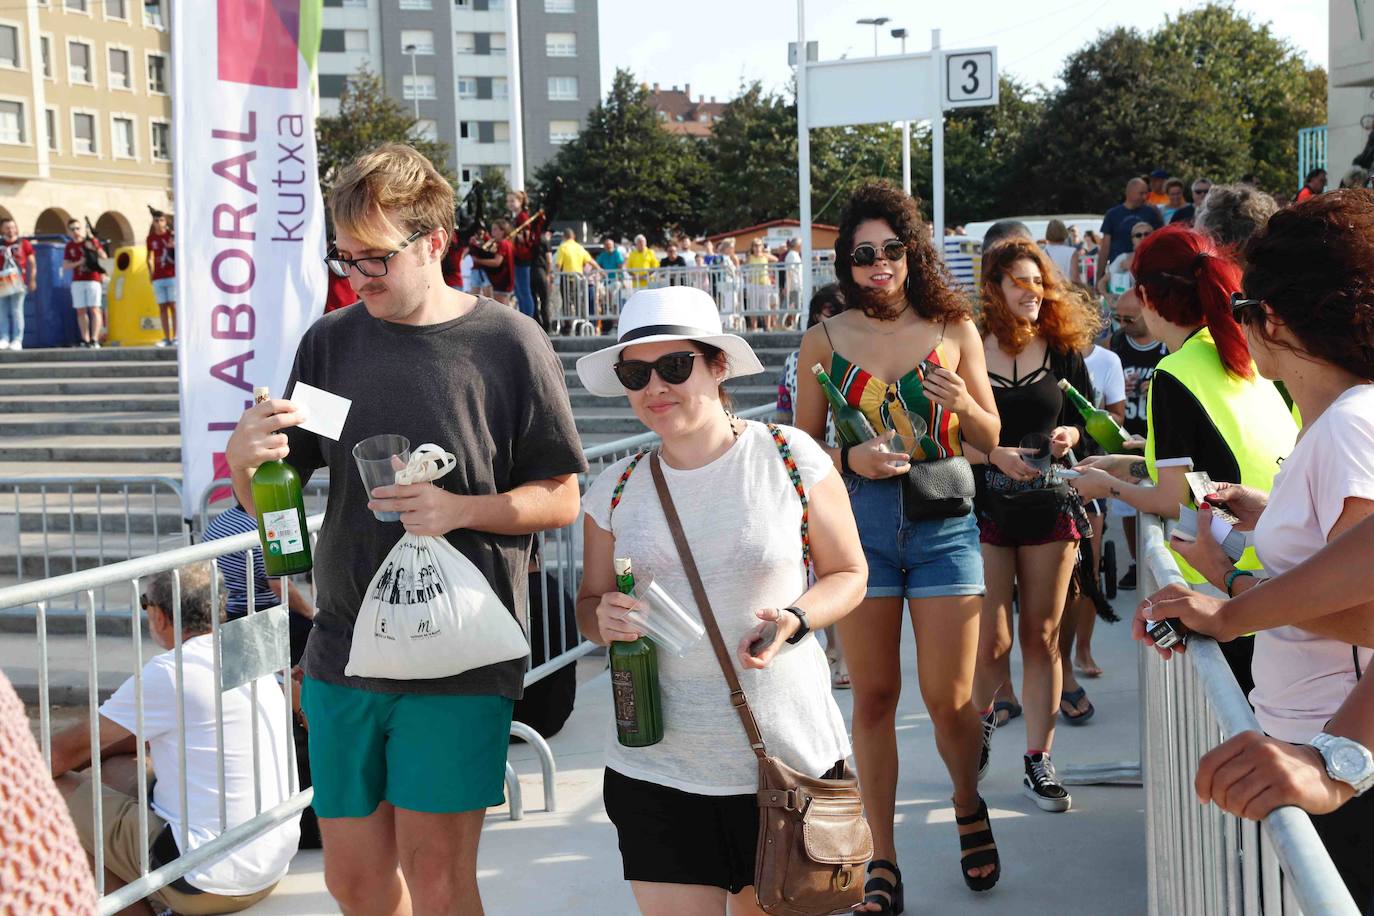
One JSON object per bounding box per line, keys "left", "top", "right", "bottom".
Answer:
{"left": 319, "top": 0, "right": 600, "bottom": 190}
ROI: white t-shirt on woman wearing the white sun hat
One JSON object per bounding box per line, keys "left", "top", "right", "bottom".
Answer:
{"left": 583, "top": 423, "right": 849, "bottom": 795}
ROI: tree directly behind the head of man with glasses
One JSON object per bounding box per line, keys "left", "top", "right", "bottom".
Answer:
{"left": 315, "top": 67, "right": 455, "bottom": 194}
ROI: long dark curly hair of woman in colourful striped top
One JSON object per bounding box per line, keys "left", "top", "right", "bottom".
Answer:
{"left": 835, "top": 181, "right": 973, "bottom": 321}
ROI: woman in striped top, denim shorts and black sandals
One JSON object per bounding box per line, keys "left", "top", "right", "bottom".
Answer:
{"left": 796, "top": 181, "right": 1002, "bottom": 913}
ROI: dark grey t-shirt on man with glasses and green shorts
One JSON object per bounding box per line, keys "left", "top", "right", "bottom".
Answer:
{"left": 286, "top": 299, "right": 587, "bottom": 699}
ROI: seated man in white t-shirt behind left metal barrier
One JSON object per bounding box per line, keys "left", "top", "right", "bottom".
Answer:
{"left": 52, "top": 563, "right": 301, "bottom": 913}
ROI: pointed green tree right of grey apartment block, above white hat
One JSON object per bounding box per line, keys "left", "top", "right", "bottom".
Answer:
{"left": 534, "top": 70, "right": 705, "bottom": 239}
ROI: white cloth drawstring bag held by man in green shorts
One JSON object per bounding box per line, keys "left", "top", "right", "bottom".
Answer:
{"left": 344, "top": 444, "right": 529, "bottom": 680}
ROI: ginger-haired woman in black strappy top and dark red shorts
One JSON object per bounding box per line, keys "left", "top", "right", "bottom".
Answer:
{"left": 969, "top": 239, "right": 1098, "bottom": 812}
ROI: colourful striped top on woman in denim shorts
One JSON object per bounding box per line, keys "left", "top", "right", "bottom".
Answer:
{"left": 827, "top": 341, "right": 963, "bottom": 461}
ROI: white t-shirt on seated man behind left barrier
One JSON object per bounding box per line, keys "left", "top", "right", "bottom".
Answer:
{"left": 100, "top": 634, "right": 301, "bottom": 895}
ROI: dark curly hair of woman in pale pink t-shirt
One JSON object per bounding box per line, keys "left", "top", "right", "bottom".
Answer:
{"left": 1243, "top": 188, "right": 1374, "bottom": 379}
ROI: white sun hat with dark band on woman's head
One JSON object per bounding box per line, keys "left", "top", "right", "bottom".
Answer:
{"left": 577, "top": 286, "right": 764, "bottom": 397}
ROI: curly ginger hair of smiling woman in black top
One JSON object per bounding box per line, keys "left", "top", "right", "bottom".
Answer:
{"left": 978, "top": 238, "right": 1102, "bottom": 354}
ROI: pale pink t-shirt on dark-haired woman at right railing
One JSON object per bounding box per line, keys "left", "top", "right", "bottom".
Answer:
{"left": 1250, "top": 385, "right": 1374, "bottom": 742}
